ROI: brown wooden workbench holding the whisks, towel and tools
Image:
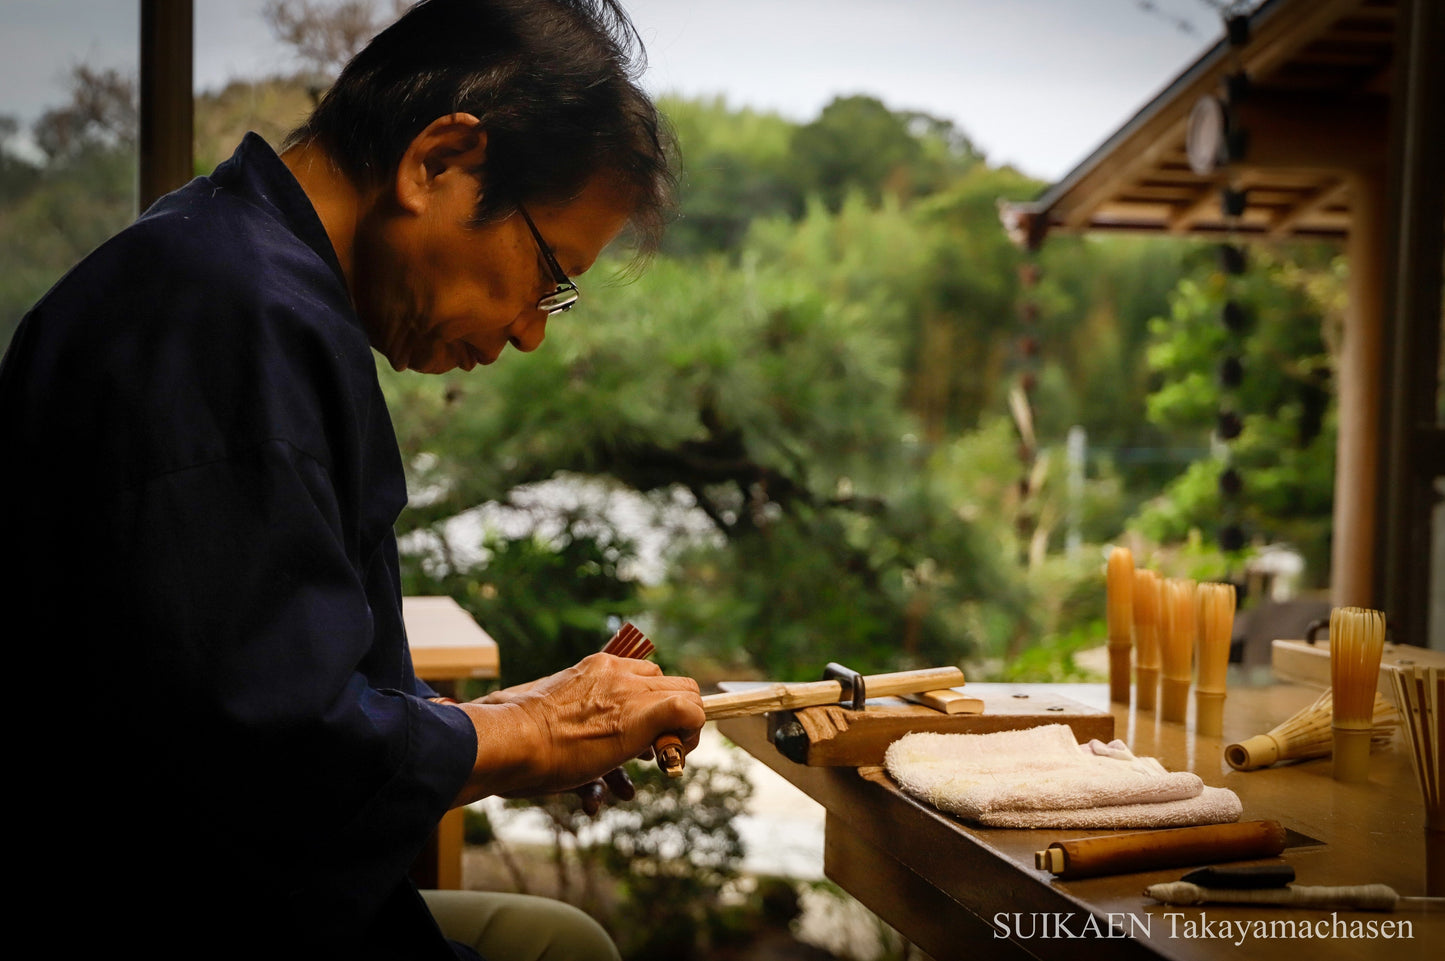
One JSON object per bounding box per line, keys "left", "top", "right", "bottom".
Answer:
{"left": 718, "top": 679, "right": 1445, "bottom": 961}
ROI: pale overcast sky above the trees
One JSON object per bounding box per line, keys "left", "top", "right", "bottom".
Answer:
{"left": 0, "top": 0, "right": 1221, "bottom": 181}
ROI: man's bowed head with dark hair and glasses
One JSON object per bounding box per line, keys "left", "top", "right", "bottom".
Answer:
{"left": 288, "top": 0, "right": 672, "bottom": 370}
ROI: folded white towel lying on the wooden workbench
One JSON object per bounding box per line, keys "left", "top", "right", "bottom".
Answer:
{"left": 883, "top": 724, "right": 1243, "bottom": 828}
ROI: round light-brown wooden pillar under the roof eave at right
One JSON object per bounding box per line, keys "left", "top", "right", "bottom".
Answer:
{"left": 1329, "top": 169, "right": 1387, "bottom": 607}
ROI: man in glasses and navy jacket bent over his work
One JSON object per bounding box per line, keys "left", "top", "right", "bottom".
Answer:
{"left": 0, "top": 0, "right": 704, "bottom": 961}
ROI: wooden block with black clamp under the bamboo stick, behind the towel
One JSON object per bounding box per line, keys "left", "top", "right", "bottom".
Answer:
{"left": 767, "top": 685, "right": 1114, "bottom": 767}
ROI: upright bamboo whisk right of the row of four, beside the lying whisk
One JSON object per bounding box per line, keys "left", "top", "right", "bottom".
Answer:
{"left": 1329, "top": 607, "right": 1384, "bottom": 782}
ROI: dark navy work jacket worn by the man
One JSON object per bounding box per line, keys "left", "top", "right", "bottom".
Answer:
{"left": 0, "top": 134, "right": 475, "bottom": 958}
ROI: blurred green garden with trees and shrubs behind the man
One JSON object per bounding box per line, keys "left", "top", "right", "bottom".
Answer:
{"left": 0, "top": 3, "right": 1344, "bottom": 958}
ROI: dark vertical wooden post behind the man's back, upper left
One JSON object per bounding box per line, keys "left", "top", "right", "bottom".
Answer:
{"left": 137, "top": 0, "right": 195, "bottom": 211}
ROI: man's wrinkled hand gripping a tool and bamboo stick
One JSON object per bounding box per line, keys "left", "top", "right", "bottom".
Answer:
{"left": 447, "top": 653, "right": 705, "bottom": 812}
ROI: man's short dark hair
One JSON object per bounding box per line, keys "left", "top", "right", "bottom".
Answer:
{"left": 286, "top": 0, "right": 673, "bottom": 250}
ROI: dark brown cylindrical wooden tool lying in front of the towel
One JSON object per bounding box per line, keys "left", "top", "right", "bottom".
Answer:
{"left": 1033, "top": 821, "right": 1285, "bottom": 879}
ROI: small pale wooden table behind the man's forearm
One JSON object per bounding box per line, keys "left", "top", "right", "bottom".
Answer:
{"left": 402, "top": 597, "right": 500, "bottom": 889}
